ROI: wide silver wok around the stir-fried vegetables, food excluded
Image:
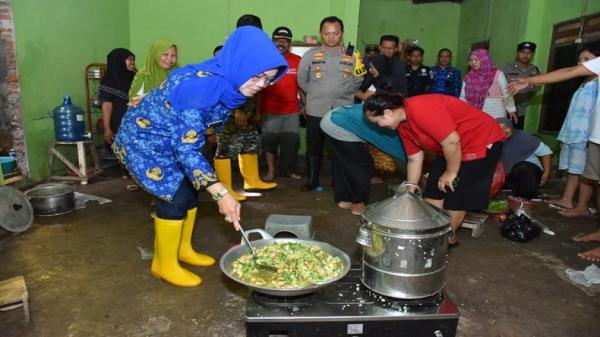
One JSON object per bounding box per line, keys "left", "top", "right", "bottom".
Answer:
{"left": 220, "top": 229, "right": 350, "bottom": 296}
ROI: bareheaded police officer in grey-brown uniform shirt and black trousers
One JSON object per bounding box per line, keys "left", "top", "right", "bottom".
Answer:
{"left": 298, "top": 16, "right": 366, "bottom": 191}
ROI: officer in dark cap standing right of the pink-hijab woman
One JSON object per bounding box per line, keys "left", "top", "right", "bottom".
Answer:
{"left": 502, "top": 42, "right": 541, "bottom": 129}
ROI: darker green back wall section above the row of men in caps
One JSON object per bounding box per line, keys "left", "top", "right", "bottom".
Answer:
{"left": 358, "top": 0, "right": 461, "bottom": 65}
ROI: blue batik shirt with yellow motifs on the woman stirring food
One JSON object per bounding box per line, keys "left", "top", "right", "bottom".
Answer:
{"left": 113, "top": 70, "right": 230, "bottom": 201}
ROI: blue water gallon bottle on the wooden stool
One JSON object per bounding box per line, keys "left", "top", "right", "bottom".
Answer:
{"left": 52, "top": 96, "right": 86, "bottom": 142}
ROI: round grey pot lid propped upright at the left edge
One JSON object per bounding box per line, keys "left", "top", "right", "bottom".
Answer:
{"left": 0, "top": 186, "right": 33, "bottom": 232}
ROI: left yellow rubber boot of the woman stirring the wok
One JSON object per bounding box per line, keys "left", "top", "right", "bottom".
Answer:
{"left": 150, "top": 217, "right": 202, "bottom": 287}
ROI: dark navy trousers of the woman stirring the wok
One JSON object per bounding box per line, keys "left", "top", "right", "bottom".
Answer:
{"left": 156, "top": 178, "right": 198, "bottom": 220}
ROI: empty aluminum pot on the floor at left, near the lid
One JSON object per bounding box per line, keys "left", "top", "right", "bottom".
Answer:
{"left": 25, "top": 183, "right": 75, "bottom": 216}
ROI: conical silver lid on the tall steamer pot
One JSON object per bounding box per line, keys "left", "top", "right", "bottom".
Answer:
{"left": 362, "top": 185, "right": 450, "bottom": 233}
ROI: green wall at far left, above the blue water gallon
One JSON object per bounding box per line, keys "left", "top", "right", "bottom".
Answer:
{"left": 12, "top": 0, "right": 129, "bottom": 181}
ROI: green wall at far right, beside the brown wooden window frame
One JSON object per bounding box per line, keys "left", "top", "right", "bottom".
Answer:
{"left": 457, "top": 0, "right": 600, "bottom": 145}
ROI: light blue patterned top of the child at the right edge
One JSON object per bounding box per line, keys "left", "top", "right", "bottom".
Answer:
{"left": 556, "top": 79, "right": 598, "bottom": 144}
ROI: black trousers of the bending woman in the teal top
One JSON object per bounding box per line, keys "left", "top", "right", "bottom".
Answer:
{"left": 329, "top": 137, "right": 373, "bottom": 204}
